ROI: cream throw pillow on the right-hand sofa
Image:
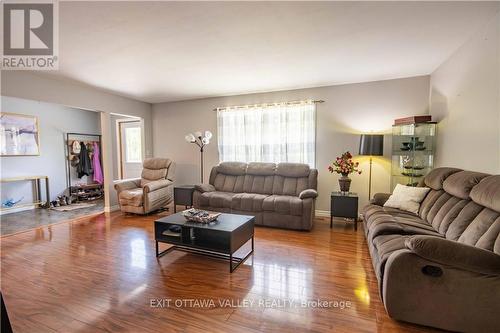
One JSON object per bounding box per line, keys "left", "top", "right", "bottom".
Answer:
{"left": 384, "top": 184, "right": 430, "bottom": 214}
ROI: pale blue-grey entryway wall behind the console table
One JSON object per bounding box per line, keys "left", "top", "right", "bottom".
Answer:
{"left": 0, "top": 97, "right": 101, "bottom": 208}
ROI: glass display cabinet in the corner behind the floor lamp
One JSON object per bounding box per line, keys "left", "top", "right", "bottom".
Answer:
{"left": 391, "top": 122, "right": 436, "bottom": 191}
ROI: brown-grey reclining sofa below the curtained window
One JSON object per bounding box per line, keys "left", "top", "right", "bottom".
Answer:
{"left": 193, "top": 162, "right": 318, "bottom": 230}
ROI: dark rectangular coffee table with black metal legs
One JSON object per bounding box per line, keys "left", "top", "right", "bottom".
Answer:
{"left": 155, "top": 213, "right": 255, "bottom": 273}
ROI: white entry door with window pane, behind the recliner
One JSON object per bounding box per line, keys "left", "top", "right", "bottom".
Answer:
{"left": 120, "top": 120, "right": 143, "bottom": 179}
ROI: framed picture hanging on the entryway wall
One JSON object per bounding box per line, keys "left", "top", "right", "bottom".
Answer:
{"left": 0, "top": 112, "right": 40, "bottom": 156}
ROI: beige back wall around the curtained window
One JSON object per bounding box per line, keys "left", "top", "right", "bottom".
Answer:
{"left": 153, "top": 76, "right": 429, "bottom": 211}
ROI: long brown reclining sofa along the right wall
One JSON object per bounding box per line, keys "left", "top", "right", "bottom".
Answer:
{"left": 364, "top": 168, "right": 500, "bottom": 332}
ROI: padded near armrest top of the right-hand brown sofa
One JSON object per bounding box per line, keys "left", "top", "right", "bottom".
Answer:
{"left": 405, "top": 235, "right": 500, "bottom": 275}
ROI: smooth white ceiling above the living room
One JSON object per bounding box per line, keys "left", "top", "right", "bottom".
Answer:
{"left": 44, "top": 2, "right": 499, "bottom": 103}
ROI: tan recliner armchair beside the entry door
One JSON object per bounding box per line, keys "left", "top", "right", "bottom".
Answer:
{"left": 115, "top": 158, "right": 175, "bottom": 214}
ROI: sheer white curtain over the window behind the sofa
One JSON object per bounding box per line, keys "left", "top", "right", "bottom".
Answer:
{"left": 217, "top": 101, "right": 316, "bottom": 167}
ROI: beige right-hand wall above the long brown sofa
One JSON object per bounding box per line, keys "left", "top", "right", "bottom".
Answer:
{"left": 430, "top": 14, "right": 500, "bottom": 174}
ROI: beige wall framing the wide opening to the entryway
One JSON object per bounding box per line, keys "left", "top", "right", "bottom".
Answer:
{"left": 1, "top": 71, "right": 153, "bottom": 210}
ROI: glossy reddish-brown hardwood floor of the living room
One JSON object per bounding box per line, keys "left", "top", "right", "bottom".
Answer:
{"left": 1, "top": 213, "right": 440, "bottom": 333}
